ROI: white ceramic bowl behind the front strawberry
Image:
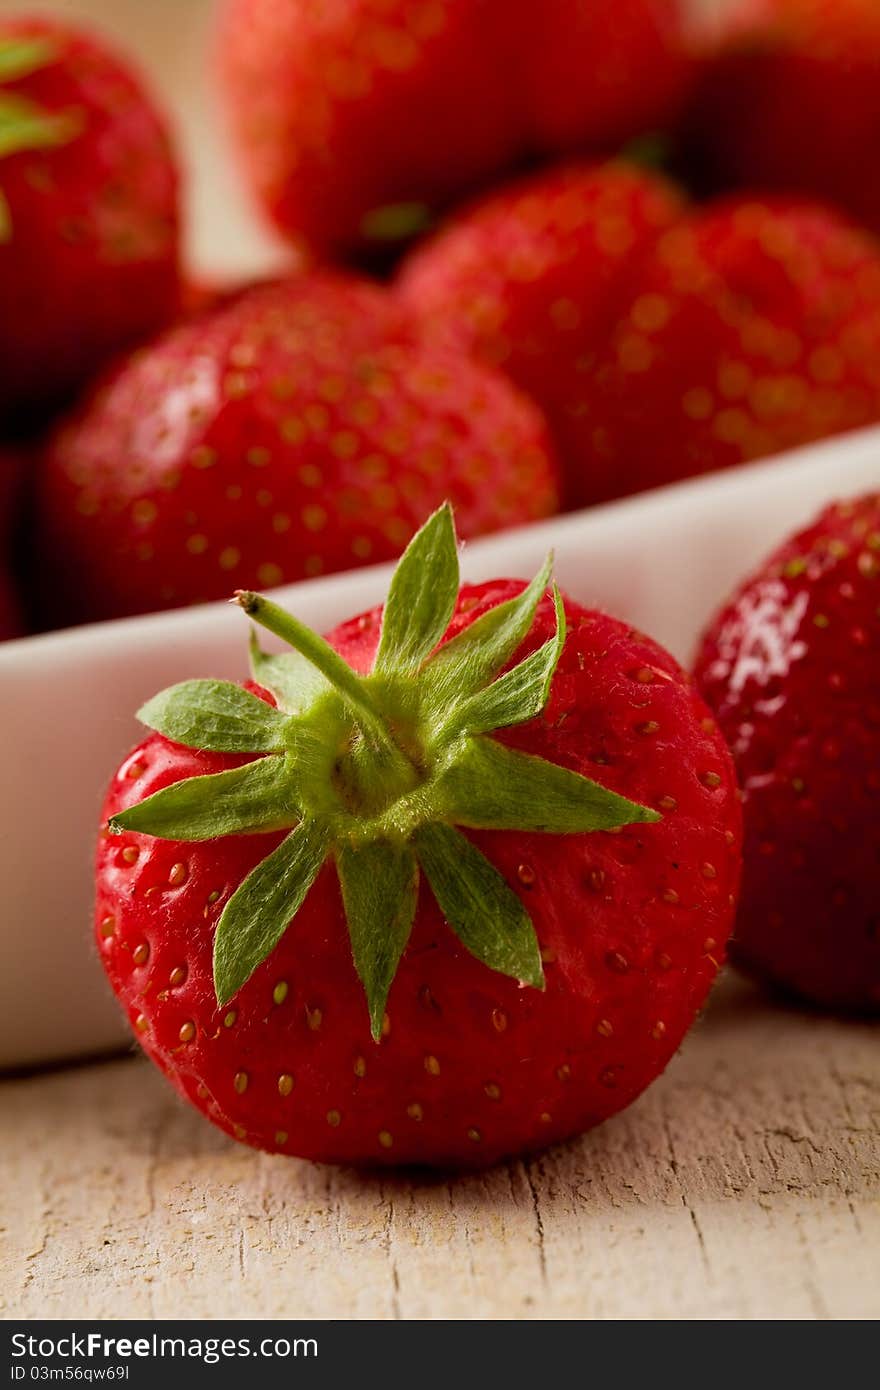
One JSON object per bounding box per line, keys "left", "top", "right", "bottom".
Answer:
{"left": 0, "top": 430, "right": 880, "bottom": 1068}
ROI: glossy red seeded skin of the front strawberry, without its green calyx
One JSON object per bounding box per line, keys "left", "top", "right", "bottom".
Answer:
{"left": 96, "top": 581, "right": 741, "bottom": 1166}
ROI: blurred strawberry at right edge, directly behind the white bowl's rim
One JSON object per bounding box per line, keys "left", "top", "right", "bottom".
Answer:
{"left": 572, "top": 197, "right": 880, "bottom": 498}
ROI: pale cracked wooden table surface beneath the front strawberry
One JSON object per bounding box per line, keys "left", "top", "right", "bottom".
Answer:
{"left": 0, "top": 980, "right": 880, "bottom": 1319}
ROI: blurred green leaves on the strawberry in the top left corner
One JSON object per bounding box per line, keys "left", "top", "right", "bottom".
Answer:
{"left": 0, "top": 33, "right": 82, "bottom": 245}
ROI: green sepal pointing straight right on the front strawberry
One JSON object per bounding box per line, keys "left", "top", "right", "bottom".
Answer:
{"left": 435, "top": 738, "right": 660, "bottom": 835}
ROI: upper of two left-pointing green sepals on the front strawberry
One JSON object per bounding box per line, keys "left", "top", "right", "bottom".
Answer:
{"left": 138, "top": 681, "right": 291, "bottom": 753}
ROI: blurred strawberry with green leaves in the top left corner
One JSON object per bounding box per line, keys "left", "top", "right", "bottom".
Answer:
{"left": 0, "top": 17, "right": 178, "bottom": 417}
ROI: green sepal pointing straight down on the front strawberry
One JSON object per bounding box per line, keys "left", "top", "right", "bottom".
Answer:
{"left": 336, "top": 841, "right": 418, "bottom": 1043}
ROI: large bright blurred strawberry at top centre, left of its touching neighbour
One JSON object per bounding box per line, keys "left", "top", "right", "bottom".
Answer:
{"left": 220, "top": 0, "right": 520, "bottom": 261}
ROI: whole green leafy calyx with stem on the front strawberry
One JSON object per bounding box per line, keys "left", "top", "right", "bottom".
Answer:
{"left": 108, "top": 505, "right": 660, "bottom": 1040}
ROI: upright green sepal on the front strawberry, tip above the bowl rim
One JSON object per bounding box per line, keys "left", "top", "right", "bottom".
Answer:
{"left": 374, "top": 502, "right": 459, "bottom": 676}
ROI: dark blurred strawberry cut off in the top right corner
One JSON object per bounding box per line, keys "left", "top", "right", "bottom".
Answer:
{"left": 691, "top": 0, "right": 880, "bottom": 232}
